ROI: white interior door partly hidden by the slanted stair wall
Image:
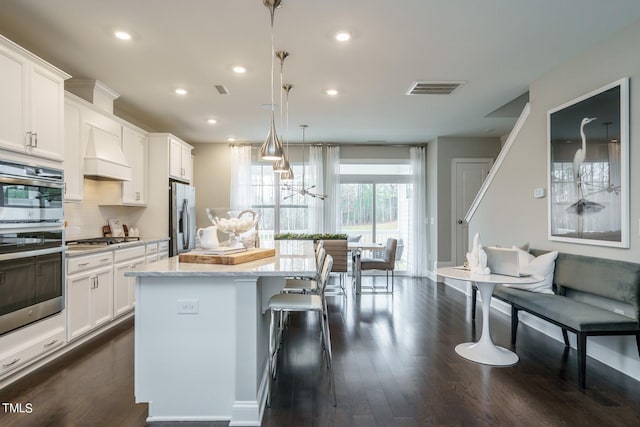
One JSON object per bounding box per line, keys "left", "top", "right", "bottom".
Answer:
{"left": 451, "top": 158, "right": 493, "bottom": 265}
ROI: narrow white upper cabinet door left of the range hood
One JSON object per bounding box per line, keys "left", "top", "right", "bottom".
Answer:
{"left": 64, "top": 102, "right": 84, "bottom": 202}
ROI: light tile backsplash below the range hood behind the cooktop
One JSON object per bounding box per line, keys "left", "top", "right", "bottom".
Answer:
{"left": 64, "top": 179, "right": 145, "bottom": 240}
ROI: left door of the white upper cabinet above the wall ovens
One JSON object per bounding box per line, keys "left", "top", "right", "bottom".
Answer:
{"left": 0, "top": 46, "right": 28, "bottom": 152}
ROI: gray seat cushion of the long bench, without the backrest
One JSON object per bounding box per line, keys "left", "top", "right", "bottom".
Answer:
{"left": 493, "top": 285, "right": 638, "bottom": 332}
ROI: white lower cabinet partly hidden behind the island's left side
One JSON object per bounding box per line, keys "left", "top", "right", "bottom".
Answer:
{"left": 113, "top": 245, "right": 145, "bottom": 317}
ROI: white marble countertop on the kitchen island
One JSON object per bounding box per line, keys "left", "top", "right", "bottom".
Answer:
{"left": 125, "top": 240, "right": 316, "bottom": 277}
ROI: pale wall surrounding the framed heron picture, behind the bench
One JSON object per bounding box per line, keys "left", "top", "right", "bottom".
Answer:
{"left": 469, "top": 22, "right": 640, "bottom": 379}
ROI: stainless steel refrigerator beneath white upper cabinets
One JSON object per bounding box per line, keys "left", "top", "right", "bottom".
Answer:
{"left": 169, "top": 181, "right": 196, "bottom": 256}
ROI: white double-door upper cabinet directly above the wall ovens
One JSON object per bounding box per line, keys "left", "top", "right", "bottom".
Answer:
{"left": 0, "top": 36, "right": 69, "bottom": 161}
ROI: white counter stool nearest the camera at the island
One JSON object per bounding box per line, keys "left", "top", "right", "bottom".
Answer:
{"left": 267, "top": 255, "right": 337, "bottom": 406}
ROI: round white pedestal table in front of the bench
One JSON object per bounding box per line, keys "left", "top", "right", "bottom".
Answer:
{"left": 436, "top": 267, "right": 543, "bottom": 366}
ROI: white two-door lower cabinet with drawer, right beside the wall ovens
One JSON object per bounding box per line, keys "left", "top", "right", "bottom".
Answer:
{"left": 66, "top": 252, "right": 113, "bottom": 341}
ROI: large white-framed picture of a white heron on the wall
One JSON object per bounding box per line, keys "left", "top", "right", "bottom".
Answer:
{"left": 547, "top": 77, "right": 629, "bottom": 248}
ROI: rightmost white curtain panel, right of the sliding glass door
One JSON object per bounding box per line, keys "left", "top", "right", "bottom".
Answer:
{"left": 405, "top": 147, "right": 429, "bottom": 277}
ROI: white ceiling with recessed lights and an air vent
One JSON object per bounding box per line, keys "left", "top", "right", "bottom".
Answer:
{"left": 0, "top": 0, "right": 640, "bottom": 144}
